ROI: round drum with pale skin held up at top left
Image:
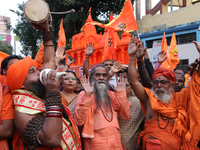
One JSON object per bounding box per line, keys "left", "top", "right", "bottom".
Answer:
{"left": 24, "top": 0, "right": 52, "bottom": 24}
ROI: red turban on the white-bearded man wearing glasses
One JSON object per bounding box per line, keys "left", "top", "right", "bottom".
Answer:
{"left": 152, "top": 67, "right": 176, "bottom": 82}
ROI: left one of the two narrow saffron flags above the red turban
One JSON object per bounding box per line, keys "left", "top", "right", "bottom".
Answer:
{"left": 160, "top": 32, "right": 171, "bottom": 69}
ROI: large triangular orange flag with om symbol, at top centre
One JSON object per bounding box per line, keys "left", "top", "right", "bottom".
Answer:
{"left": 106, "top": 0, "right": 137, "bottom": 32}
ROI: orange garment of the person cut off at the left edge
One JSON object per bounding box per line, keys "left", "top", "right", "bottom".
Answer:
{"left": 0, "top": 84, "right": 15, "bottom": 150}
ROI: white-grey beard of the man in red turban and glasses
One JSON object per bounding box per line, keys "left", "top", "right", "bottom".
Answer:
{"left": 151, "top": 87, "right": 173, "bottom": 104}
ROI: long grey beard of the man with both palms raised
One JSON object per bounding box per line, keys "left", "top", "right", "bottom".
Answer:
{"left": 94, "top": 80, "right": 110, "bottom": 109}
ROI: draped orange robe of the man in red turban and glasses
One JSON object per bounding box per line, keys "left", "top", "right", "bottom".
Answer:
{"left": 141, "top": 72, "right": 200, "bottom": 150}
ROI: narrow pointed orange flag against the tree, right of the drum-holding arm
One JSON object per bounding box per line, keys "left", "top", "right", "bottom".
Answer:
{"left": 57, "top": 18, "right": 66, "bottom": 49}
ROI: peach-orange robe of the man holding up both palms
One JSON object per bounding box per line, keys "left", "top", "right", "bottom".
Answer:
{"left": 74, "top": 89, "right": 130, "bottom": 150}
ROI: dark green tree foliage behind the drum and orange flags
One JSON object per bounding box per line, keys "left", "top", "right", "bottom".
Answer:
{"left": 13, "top": 0, "right": 134, "bottom": 58}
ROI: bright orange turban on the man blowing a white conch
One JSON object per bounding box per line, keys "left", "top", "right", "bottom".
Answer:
{"left": 7, "top": 56, "right": 37, "bottom": 91}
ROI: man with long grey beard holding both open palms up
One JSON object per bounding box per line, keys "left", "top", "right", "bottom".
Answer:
{"left": 74, "top": 65, "right": 130, "bottom": 150}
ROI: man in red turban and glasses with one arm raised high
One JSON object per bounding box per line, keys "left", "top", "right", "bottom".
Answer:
{"left": 128, "top": 37, "right": 200, "bottom": 150}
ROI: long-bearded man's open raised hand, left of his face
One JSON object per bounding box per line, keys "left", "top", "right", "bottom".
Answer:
{"left": 81, "top": 75, "right": 94, "bottom": 97}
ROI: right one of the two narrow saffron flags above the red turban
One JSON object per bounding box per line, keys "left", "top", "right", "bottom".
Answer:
{"left": 169, "top": 33, "right": 180, "bottom": 70}
